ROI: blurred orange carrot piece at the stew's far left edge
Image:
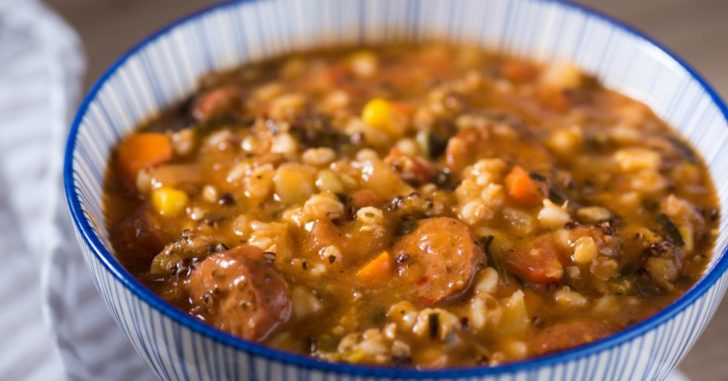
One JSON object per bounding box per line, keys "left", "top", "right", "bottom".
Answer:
{"left": 118, "top": 132, "right": 172, "bottom": 183}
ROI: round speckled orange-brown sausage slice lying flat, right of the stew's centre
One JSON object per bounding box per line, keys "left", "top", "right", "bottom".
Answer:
{"left": 393, "top": 217, "right": 485, "bottom": 306}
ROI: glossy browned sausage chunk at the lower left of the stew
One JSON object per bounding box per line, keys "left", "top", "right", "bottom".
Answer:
{"left": 189, "top": 245, "right": 291, "bottom": 341}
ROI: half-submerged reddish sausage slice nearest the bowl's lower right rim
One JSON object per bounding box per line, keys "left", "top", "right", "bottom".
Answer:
{"left": 531, "top": 320, "right": 611, "bottom": 356}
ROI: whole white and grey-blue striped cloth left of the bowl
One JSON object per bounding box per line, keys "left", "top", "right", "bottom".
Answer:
{"left": 0, "top": 0, "right": 151, "bottom": 380}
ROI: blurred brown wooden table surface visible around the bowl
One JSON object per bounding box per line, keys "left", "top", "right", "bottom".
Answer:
{"left": 46, "top": 0, "right": 728, "bottom": 381}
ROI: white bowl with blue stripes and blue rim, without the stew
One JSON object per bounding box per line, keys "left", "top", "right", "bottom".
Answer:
{"left": 64, "top": 0, "right": 728, "bottom": 380}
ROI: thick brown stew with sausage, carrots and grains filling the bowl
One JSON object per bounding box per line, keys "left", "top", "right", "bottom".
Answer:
{"left": 105, "top": 43, "right": 719, "bottom": 368}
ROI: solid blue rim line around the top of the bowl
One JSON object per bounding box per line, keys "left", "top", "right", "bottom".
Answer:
{"left": 63, "top": 0, "right": 728, "bottom": 378}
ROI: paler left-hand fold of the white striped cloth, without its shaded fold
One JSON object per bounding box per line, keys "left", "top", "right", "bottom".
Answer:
{"left": 0, "top": 1, "right": 83, "bottom": 380}
